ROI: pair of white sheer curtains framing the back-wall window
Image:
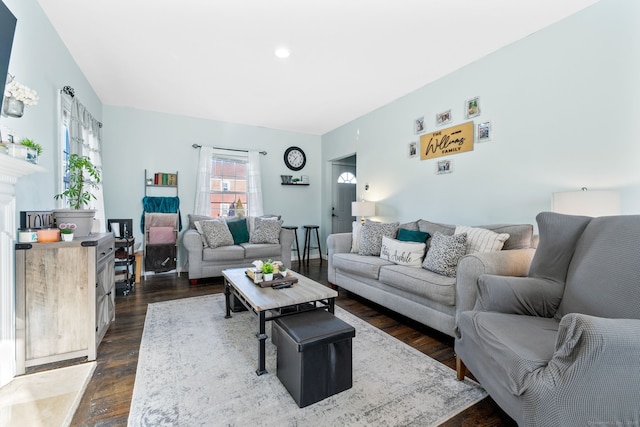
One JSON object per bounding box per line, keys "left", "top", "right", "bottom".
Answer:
{"left": 193, "top": 145, "right": 264, "bottom": 216}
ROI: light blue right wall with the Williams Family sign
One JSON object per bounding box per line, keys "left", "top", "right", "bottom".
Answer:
{"left": 322, "top": 0, "right": 640, "bottom": 241}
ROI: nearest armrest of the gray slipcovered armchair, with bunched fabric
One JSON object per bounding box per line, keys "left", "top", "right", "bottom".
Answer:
{"left": 516, "top": 313, "right": 640, "bottom": 425}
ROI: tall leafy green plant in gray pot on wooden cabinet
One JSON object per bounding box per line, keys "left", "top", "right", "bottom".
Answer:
{"left": 53, "top": 154, "right": 100, "bottom": 237}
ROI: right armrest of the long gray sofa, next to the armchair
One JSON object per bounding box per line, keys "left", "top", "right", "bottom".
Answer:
{"left": 456, "top": 249, "right": 535, "bottom": 328}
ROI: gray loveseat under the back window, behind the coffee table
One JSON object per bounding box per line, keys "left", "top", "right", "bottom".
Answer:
{"left": 182, "top": 215, "right": 294, "bottom": 282}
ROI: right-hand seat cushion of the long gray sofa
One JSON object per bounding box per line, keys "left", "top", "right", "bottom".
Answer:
{"left": 380, "top": 265, "right": 456, "bottom": 306}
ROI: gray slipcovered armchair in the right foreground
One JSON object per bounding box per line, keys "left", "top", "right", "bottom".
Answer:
{"left": 455, "top": 212, "right": 640, "bottom": 426}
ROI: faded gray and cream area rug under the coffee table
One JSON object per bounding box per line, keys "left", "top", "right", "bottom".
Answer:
{"left": 128, "top": 294, "right": 486, "bottom": 426}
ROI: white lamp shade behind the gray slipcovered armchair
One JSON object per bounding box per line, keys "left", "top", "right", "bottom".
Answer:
{"left": 551, "top": 190, "right": 620, "bottom": 217}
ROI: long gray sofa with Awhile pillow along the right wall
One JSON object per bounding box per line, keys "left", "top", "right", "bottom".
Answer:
{"left": 327, "top": 220, "right": 535, "bottom": 337}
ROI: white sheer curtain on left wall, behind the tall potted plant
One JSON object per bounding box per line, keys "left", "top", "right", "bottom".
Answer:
{"left": 60, "top": 91, "right": 106, "bottom": 232}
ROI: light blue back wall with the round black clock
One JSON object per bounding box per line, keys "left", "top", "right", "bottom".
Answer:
{"left": 102, "top": 105, "right": 322, "bottom": 262}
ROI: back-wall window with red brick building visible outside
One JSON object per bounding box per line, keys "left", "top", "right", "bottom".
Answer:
{"left": 210, "top": 157, "right": 248, "bottom": 217}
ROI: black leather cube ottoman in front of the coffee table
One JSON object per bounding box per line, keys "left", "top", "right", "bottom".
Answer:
{"left": 272, "top": 310, "right": 356, "bottom": 408}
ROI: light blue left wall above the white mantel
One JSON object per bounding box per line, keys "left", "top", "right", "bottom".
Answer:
{"left": 0, "top": 0, "right": 102, "bottom": 211}
